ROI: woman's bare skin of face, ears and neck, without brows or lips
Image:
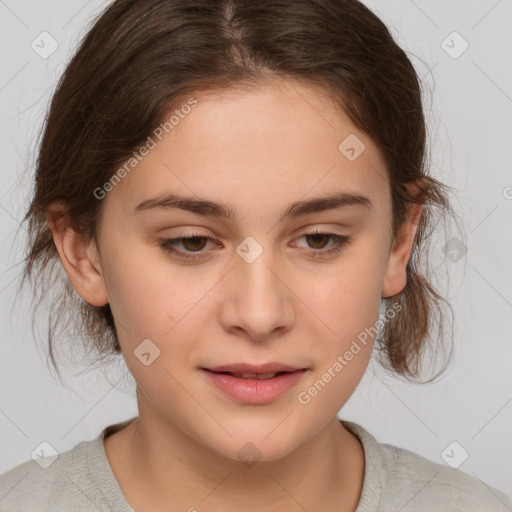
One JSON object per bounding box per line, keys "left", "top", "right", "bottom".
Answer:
{"left": 48, "top": 81, "right": 421, "bottom": 512}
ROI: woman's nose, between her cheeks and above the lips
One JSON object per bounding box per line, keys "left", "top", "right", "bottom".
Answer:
{"left": 220, "top": 246, "right": 295, "bottom": 342}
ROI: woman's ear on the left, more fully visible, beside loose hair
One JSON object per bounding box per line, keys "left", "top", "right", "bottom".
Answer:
{"left": 46, "top": 201, "right": 108, "bottom": 306}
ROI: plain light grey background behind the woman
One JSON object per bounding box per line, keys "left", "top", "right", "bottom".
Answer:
{"left": 0, "top": 0, "right": 512, "bottom": 495}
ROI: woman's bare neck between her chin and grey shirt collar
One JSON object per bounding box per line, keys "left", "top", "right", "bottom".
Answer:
{"left": 105, "top": 400, "right": 364, "bottom": 512}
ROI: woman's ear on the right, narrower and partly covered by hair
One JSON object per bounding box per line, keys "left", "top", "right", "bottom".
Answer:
{"left": 381, "top": 185, "right": 423, "bottom": 297}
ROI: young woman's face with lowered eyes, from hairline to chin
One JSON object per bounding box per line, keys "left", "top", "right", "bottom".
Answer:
{"left": 51, "top": 82, "right": 420, "bottom": 460}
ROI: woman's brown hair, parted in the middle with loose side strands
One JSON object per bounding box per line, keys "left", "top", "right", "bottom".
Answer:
{"left": 18, "top": 0, "right": 451, "bottom": 380}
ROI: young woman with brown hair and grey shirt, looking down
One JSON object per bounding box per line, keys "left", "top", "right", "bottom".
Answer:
{"left": 0, "top": 0, "right": 512, "bottom": 512}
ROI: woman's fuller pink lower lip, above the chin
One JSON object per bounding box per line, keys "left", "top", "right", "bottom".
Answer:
{"left": 201, "top": 369, "right": 306, "bottom": 404}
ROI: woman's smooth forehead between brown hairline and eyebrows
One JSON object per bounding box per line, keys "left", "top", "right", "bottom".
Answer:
{"left": 107, "top": 82, "right": 389, "bottom": 219}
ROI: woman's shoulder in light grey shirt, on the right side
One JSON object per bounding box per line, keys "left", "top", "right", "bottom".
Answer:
{"left": 343, "top": 422, "right": 512, "bottom": 512}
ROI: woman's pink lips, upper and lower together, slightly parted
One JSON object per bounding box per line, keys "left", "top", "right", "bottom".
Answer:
{"left": 201, "top": 363, "right": 307, "bottom": 405}
